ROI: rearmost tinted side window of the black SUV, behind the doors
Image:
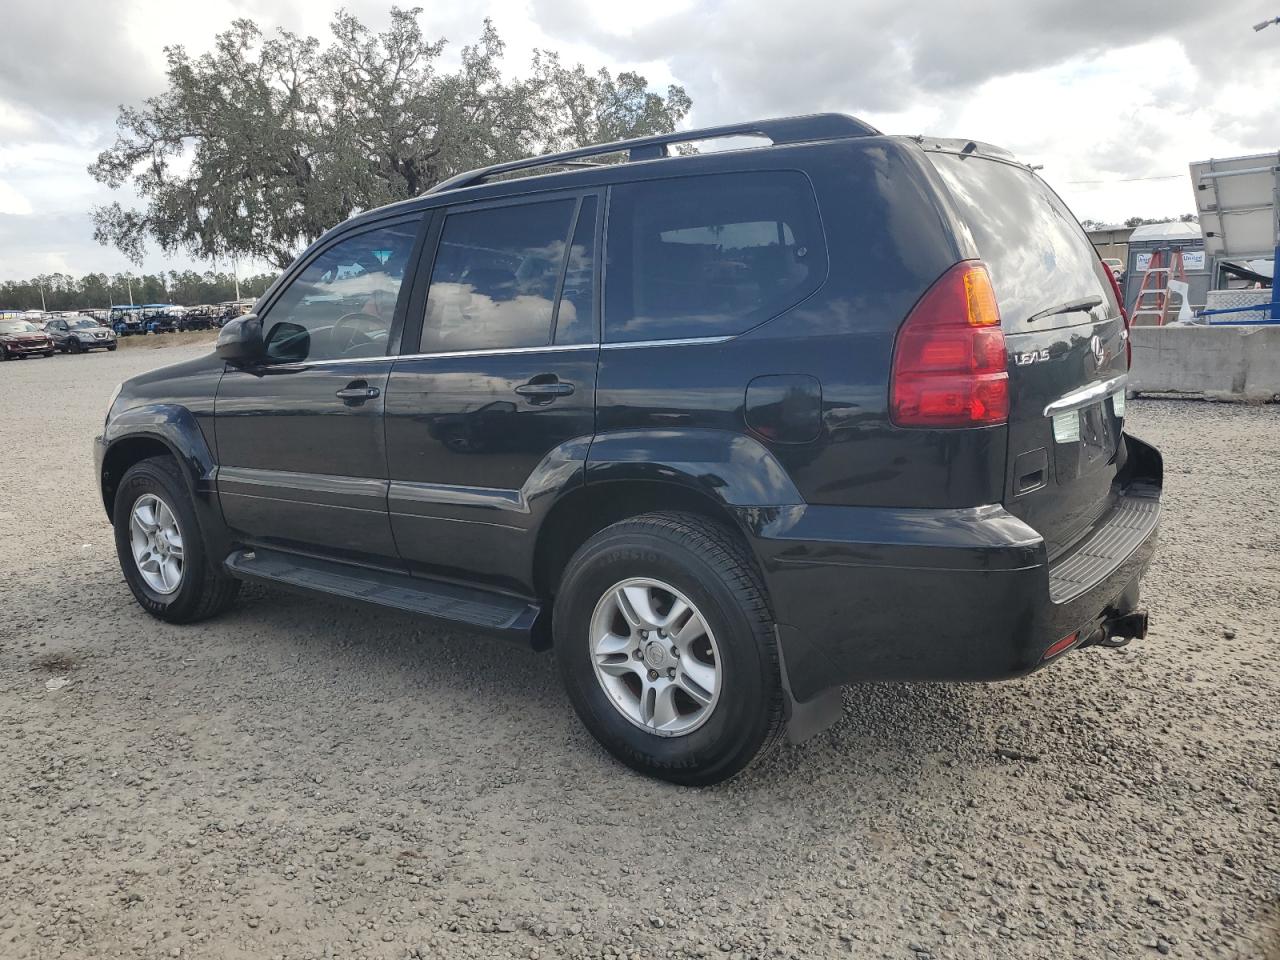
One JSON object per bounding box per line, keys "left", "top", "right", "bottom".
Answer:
{"left": 604, "top": 172, "right": 827, "bottom": 343}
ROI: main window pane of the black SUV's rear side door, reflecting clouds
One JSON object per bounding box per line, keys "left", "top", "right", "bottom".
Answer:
{"left": 422, "top": 198, "right": 577, "bottom": 353}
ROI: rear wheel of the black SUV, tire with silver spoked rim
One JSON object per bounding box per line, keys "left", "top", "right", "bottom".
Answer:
{"left": 553, "top": 513, "right": 783, "bottom": 786}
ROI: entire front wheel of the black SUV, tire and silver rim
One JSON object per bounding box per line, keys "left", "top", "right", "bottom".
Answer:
{"left": 111, "top": 457, "right": 239, "bottom": 623}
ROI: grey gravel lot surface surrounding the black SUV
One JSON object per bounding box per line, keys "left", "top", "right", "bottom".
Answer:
{"left": 0, "top": 347, "right": 1280, "bottom": 960}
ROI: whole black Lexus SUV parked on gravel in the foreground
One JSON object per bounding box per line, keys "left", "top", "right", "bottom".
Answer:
{"left": 97, "top": 115, "right": 1162, "bottom": 783}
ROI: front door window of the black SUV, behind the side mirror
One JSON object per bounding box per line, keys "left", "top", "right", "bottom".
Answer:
{"left": 262, "top": 223, "right": 417, "bottom": 362}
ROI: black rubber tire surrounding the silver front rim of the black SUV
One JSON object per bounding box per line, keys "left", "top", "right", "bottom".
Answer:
{"left": 111, "top": 457, "right": 239, "bottom": 623}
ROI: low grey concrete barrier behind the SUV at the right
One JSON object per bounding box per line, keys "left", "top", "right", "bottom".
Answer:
{"left": 1129, "top": 325, "right": 1280, "bottom": 401}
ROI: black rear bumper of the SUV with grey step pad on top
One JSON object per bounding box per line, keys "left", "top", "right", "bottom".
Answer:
{"left": 742, "top": 435, "right": 1162, "bottom": 701}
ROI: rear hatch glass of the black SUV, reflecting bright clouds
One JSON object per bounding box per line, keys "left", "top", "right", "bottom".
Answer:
{"left": 929, "top": 152, "right": 1119, "bottom": 333}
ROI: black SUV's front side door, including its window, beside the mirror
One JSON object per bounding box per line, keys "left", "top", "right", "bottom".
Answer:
{"left": 214, "top": 218, "right": 420, "bottom": 564}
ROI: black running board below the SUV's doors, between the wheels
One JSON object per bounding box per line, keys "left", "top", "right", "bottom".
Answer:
{"left": 225, "top": 548, "right": 541, "bottom": 643}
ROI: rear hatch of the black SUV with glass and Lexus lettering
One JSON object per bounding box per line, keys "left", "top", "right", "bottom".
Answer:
{"left": 928, "top": 145, "right": 1129, "bottom": 558}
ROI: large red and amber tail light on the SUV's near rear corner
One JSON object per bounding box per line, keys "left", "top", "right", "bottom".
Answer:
{"left": 890, "top": 260, "right": 1009, "bottom": 428}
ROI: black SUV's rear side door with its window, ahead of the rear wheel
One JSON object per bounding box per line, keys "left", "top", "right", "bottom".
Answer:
{"left": 387, "top": 193, "right": 600, "bottom": 593}
